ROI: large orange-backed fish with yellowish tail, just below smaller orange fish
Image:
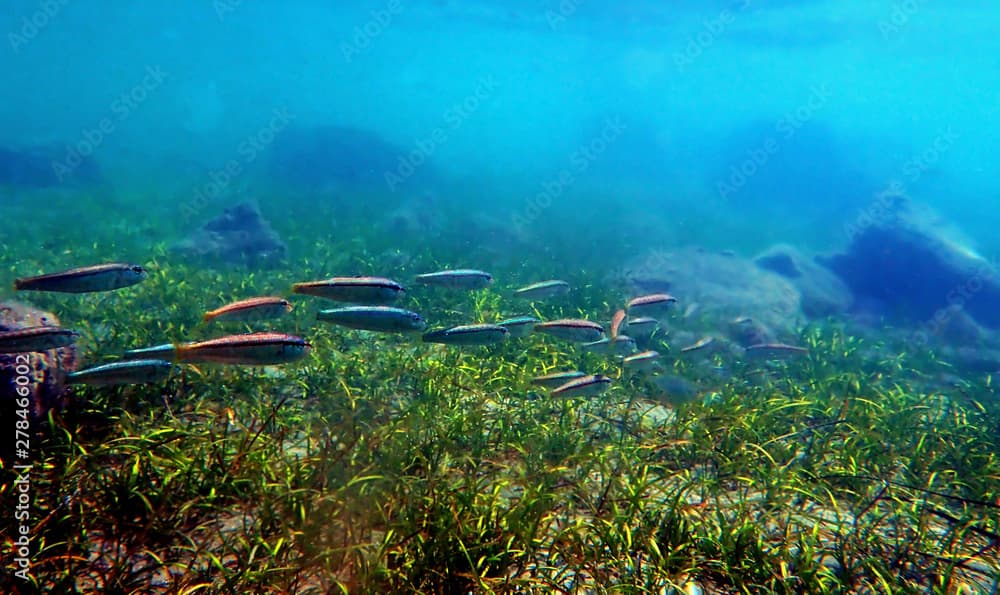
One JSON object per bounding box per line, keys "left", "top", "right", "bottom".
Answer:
{"left": 175, "top": 333, "right": 312, "bottom": 366}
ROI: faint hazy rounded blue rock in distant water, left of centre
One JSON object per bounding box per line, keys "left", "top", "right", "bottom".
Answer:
{"left": 268, "top": 125, "right": 434, "bottom": 192}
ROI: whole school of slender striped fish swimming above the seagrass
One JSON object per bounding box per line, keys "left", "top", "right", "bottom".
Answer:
{"left": 0, "top": 263, "right": 807, "bottom": 397}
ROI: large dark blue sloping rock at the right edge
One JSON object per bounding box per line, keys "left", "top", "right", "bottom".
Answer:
{"left": 818, "top": 195, "right": 1000, "bottom": 335}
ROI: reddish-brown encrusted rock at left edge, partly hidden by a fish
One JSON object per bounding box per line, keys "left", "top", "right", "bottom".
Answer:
{"left": 0, "top": 301, "right": 76, "bottom": 424}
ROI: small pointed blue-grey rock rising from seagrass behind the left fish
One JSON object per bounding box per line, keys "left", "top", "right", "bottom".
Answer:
{"left": 172, "top": 202, "right": 286, "bottom": 266}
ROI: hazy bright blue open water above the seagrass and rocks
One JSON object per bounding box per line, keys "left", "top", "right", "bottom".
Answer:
{"left": 0, "top": 0, "right": 1000, "bottom": 249}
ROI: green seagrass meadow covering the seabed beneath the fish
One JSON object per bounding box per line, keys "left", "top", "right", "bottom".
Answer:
{"left": 0, "top": 197, "right": 1000, "bottom": 594}
